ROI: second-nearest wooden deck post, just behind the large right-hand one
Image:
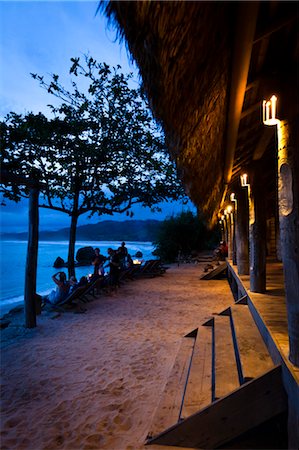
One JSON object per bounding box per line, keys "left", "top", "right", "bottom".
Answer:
{"left": 249, "top": 167, "right": 267, "bottom": 294}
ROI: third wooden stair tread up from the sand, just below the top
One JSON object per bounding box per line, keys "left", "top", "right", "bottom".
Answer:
{"left": 213, "top": 316, "right": 240, "bottom": 400}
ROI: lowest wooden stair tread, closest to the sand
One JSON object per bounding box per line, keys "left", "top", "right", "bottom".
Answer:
{"left": 148, "top": 337, "right": 195, "bottom": 437}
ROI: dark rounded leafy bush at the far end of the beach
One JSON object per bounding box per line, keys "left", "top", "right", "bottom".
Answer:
{"left": 154, "top": 211, "right": 218, "bottom": 262}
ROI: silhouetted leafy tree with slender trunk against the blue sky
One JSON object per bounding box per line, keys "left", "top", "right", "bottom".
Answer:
{"left": 1, "top": 56, "right": 183, "bottom": 275}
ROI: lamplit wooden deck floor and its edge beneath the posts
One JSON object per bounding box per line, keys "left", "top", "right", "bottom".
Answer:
{"left": 227, "top": 260, "right": 299, "bottom": 422}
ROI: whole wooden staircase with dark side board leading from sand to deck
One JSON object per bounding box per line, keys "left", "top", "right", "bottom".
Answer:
{"left": 147, "top": 298, "right": 287, "bottom": 449}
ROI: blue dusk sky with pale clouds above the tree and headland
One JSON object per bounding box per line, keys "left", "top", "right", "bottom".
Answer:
{"left": 0, "top": 0, "right": 195, "bottom": 232}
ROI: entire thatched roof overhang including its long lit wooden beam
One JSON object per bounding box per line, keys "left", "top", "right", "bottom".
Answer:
{"left": 102, "top": 1, "right": 296, "bottom": 222}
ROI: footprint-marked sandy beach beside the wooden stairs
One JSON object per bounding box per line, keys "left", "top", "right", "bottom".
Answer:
{"left": 1, "top": 263, "right": 233, "bottom": 450}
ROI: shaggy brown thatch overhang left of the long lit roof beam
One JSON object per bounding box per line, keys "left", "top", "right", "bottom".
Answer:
{"left": 100, "top": 1, "right": 234, "bottom": 223}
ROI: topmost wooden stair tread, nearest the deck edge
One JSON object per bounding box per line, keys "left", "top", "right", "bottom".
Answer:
{"left": 231, "top": 304, "right": 274, "bottom": 382}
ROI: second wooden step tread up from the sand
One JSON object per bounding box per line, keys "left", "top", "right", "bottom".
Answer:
{"left": 181, "top": 326, "right": 212, "bottom": 419}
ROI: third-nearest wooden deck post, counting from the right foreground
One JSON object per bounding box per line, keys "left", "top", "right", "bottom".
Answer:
{"left": 236, "top": 188, "right": 249, "bottom": 275}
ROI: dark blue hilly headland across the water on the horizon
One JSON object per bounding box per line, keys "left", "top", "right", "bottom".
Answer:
{"left": 0, "top": 220, "right": 162, "bottom": 242}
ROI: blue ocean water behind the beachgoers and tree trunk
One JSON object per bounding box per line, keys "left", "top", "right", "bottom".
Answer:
{"left": 0, "top": 240, "right": 155, "bottom": 316}
